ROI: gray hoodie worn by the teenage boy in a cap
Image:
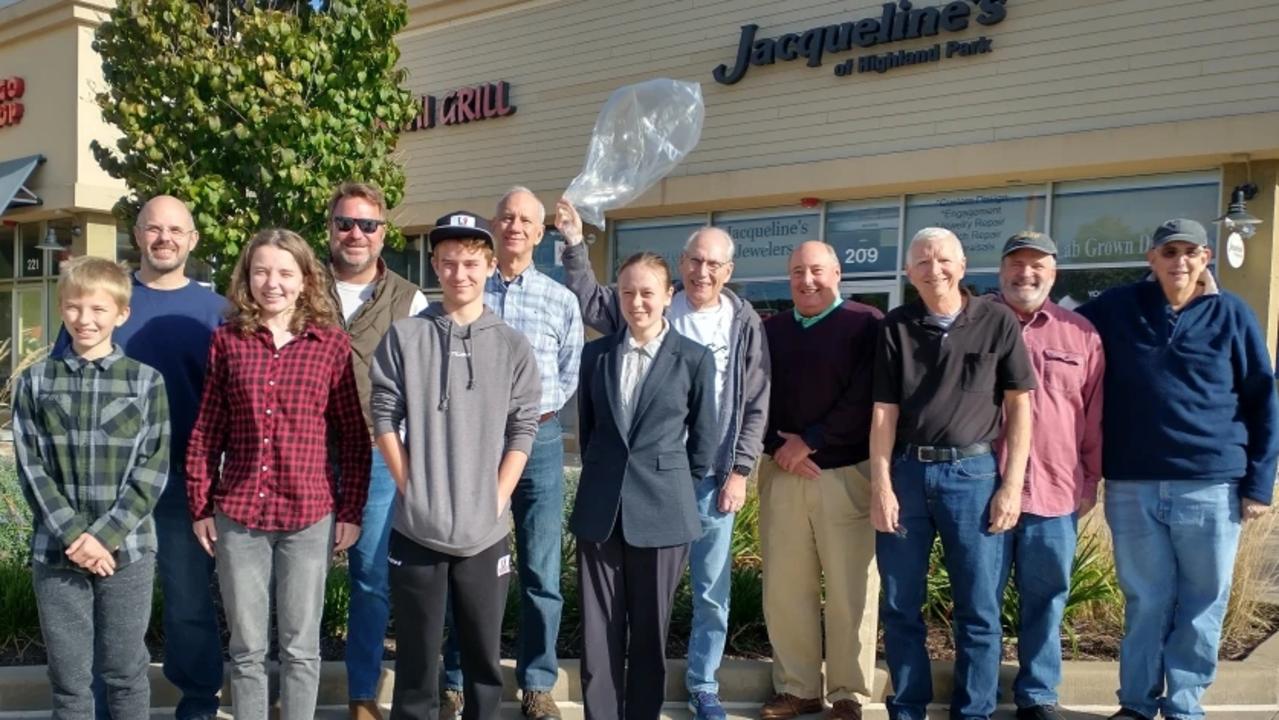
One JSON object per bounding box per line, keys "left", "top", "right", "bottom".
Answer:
{"left": 368, "top": 303, "right": 541, "bottom": 558}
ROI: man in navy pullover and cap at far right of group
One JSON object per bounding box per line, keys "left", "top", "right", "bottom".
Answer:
{"left": 1079, "top": 219, "right": 1279, "bottom": 720}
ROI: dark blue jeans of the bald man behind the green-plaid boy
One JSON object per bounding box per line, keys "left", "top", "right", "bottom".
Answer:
{"left": 93, "top": 483, "right": 223, "bottom": 720}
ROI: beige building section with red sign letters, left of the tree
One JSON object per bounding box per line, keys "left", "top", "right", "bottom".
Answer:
{"left": 0, "top": 0, "right": 129, "bottom": 380}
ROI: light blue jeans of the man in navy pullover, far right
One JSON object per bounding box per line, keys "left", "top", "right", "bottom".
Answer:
{"left": 1105, "top": 480, "right": 1241, "bottom": 720}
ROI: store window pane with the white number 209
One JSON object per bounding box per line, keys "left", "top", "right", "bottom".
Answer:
{"left": 826, "top": 198, "right": 902, "bottom": 279}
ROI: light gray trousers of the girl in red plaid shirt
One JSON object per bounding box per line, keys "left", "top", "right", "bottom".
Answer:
{"left": 216, "top": 513, "right": 334, "bottom": 720}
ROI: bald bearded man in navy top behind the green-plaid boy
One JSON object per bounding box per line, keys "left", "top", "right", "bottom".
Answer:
{"left": 52, "top": 196, "right": 226, "bottom": 720}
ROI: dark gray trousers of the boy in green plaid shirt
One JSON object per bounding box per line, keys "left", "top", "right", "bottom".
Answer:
{"left": 31, "top": 552, "right": 156, "bottom": 720}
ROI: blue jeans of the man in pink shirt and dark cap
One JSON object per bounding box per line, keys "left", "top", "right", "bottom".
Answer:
{"left": 999, "top": 513, "right": 1077, "bottom": 707}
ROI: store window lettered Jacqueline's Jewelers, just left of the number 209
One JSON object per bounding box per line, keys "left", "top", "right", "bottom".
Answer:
{"left": 711, "top": 210, "right": 821, "bottom": 280}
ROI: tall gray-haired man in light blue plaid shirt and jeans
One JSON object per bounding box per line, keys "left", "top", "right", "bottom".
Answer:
{"left": 440, "top": 187, "right": 585, "bottom": 720}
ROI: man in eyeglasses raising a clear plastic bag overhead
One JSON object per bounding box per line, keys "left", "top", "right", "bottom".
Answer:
{"left": 555, "top": 200, "right": 769, "bottom": 720}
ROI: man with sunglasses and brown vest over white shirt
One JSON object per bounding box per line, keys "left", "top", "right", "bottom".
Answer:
{"left": 329, "top": 183, "right": 427, "bottom": 720}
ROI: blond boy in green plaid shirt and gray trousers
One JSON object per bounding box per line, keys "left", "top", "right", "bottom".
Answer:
{"left": 13, "top": 257, "right": 169, "bottom": 720}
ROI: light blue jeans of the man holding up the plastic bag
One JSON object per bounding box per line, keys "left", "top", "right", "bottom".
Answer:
{"left": 684, "top": 476, "right": 734, "bottom": 694}
